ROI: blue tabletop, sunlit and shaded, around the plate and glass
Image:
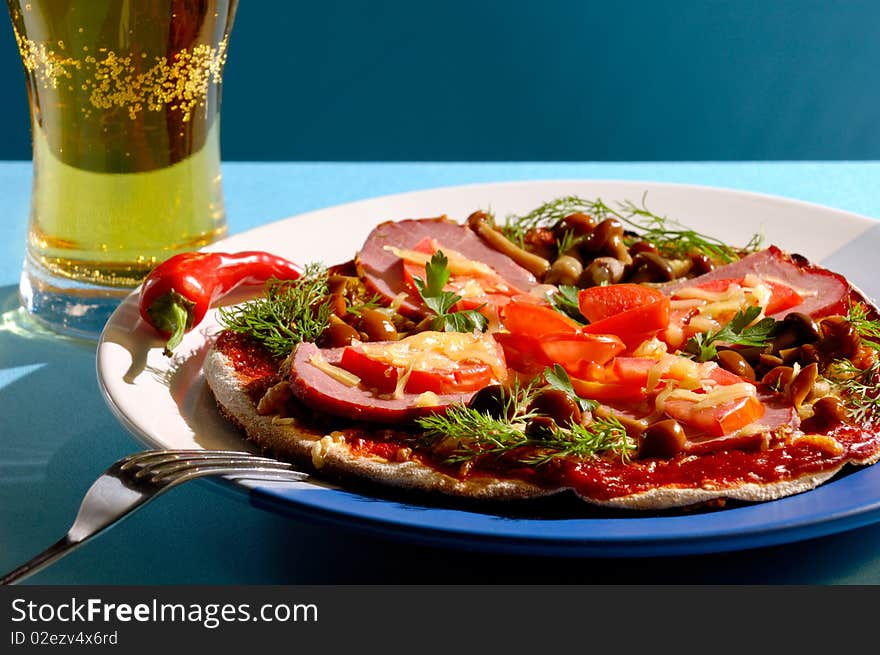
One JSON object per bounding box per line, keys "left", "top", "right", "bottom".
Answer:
{"left": 0, "top": 162, "right": 880, "bottom": 584}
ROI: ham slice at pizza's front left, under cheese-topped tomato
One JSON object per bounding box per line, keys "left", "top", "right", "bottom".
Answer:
{"left": 290, "top": 343, "right": 474, "bottom": 424}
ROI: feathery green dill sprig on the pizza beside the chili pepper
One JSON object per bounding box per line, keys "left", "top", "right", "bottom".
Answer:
{"left": 219, "top": 264, "right": 330, "bottom": 357}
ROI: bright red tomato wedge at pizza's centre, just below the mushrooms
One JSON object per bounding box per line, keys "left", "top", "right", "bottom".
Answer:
{"left": 578, "top": 284, "right": 670, "bottom": 350}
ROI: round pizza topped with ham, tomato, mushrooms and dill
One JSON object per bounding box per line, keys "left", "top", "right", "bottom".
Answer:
{"left": 198, "top": 197, "right": 880, "bottom": 510}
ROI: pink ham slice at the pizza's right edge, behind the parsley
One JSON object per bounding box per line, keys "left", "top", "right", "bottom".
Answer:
{"left": 661, "top": 246, "right": 852, "bottom": 319}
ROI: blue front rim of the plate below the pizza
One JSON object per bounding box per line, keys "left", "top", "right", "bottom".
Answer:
{"left": 250, "top": 467, "right": 880, "bottom": 557}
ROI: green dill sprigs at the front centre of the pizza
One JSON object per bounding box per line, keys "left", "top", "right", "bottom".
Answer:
{"left": 414, "top": 384, "right": 636, "bottom": 466}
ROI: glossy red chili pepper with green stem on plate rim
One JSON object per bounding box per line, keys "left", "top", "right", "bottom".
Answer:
{"left": 139, "top": 250, "right": 302, "bottom": 356}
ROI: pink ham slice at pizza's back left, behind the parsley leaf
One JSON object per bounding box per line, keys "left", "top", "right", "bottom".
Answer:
{"left": 355, "top": 217, "right": 537, "bottom": 318}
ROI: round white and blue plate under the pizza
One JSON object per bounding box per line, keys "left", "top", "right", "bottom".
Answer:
{"left": 97, "top": 180, "right": 880, "bottom": 557}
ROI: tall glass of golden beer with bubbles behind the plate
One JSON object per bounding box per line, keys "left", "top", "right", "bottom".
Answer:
{"left": 7, "top": 0, "right": 237, "bottom": 339}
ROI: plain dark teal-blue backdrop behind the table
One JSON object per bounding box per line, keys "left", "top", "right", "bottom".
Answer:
{"left": 0, "top": 0, "right": 880, "bottom": 161}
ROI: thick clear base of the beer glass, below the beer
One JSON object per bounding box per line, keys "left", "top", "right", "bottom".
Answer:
{"left": 18, "top": 257, "right": 132, "bottom": 341}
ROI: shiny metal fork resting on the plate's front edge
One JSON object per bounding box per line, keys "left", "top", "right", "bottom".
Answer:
{"left": 0, "top": 450, "right": 308, "bottom": 585}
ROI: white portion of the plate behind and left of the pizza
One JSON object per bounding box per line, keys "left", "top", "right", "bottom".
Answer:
{"left": 97, "top": 180, "right": 877, "bottom": 552}
